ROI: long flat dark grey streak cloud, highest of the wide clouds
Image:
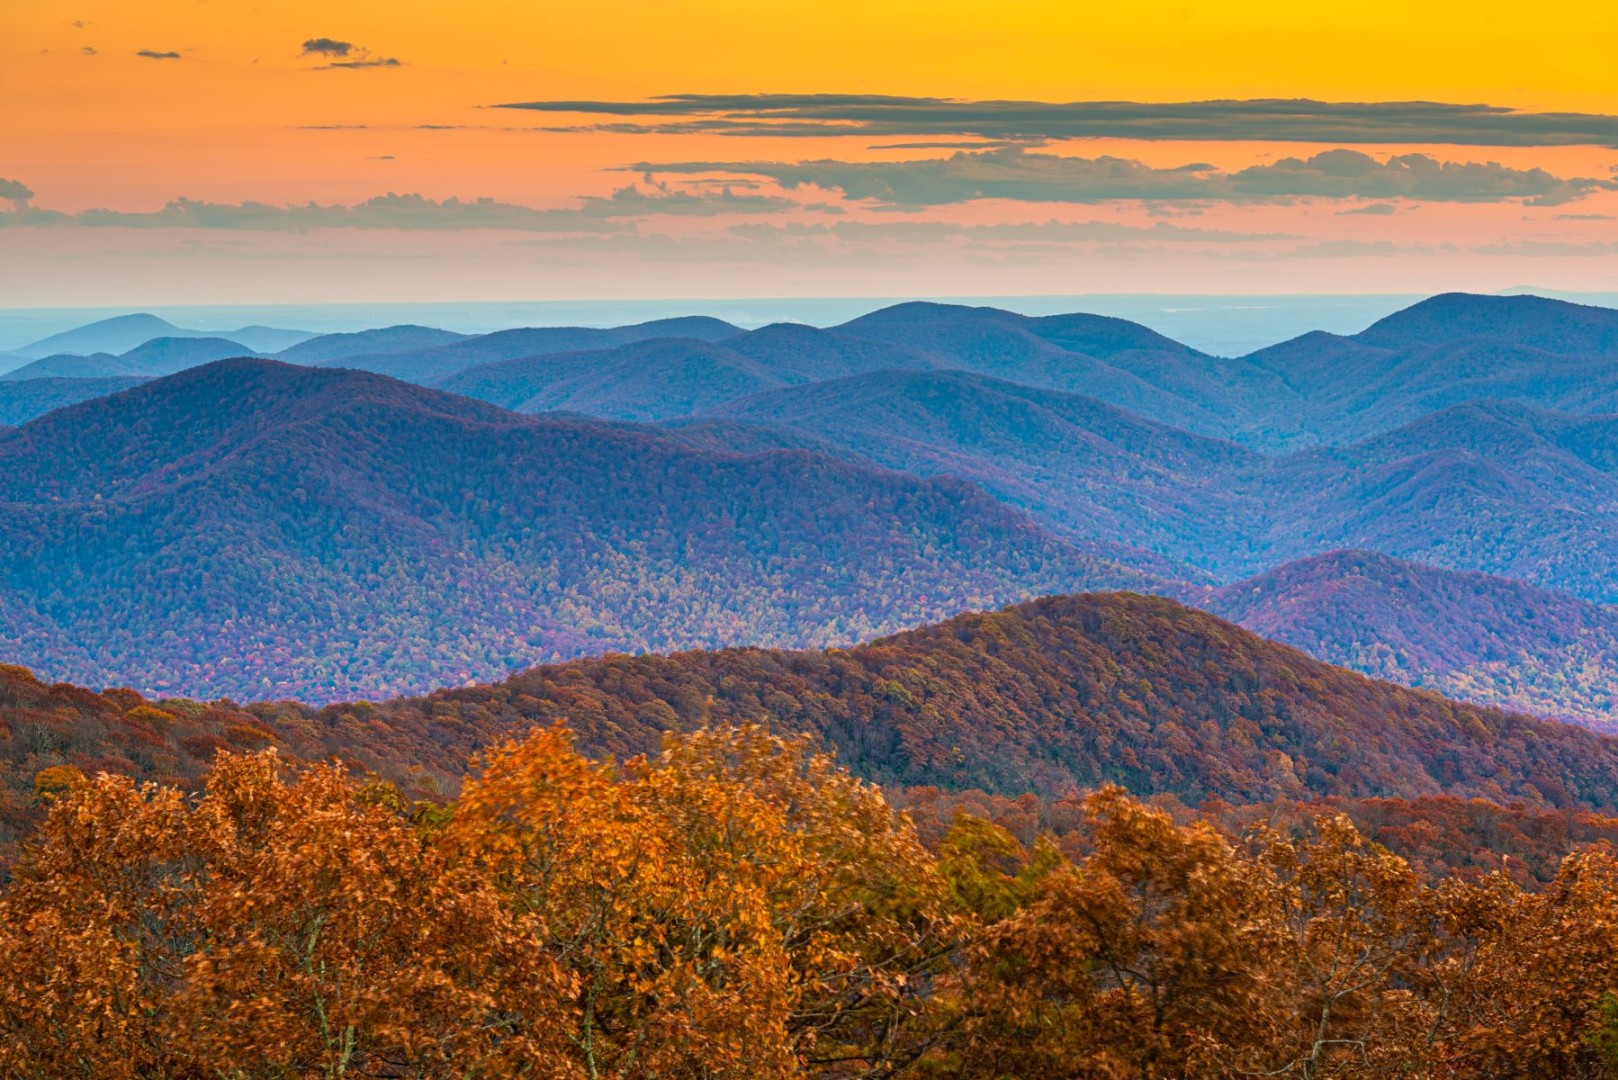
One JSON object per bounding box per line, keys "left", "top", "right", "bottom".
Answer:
{"left": 497, "top": 94, "right": 1618, "bottom": 147}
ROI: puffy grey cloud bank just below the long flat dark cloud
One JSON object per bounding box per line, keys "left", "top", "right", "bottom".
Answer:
{"left": 626, "top": 147, "right": 1618, "bottom": 207}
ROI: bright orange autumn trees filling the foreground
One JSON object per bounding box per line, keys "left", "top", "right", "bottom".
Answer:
{"left": 9, "top": 727, "right": 1618, "bottom": 1080}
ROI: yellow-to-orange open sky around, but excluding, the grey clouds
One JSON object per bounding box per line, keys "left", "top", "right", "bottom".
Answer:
{"left": 0, "top": 0, "right": 1618, "bottom": 303}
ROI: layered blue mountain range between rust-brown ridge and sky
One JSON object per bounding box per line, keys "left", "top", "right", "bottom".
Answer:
{"left": 0, "top": 295, "right": 1618, "bottom": 725}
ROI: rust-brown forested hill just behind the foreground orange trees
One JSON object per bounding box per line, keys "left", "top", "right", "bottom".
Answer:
{"left": 234, "top": 594, "right": 1618, "bottom": 806}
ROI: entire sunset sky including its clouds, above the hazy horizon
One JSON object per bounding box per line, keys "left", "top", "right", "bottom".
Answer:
{"left": 0, "top": 0, "right": 1618, "bottom": 308}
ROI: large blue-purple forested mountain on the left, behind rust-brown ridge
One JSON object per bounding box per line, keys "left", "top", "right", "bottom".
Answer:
{"left": 0, "top": 361, "right": 1160, "bottom": 699}
